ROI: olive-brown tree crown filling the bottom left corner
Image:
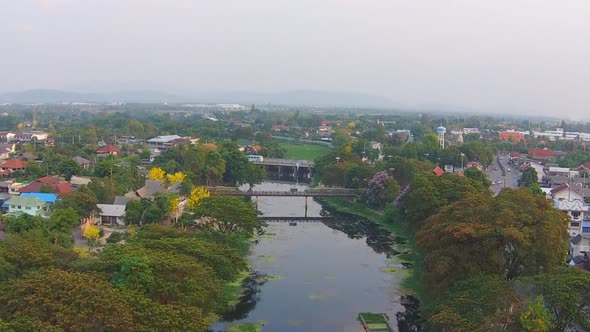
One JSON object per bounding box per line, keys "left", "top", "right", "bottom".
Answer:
{"left": 0, "top": 270, "right": 134, "bottom": 331}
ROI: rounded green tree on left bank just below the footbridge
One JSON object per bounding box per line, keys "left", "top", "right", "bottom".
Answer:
{"left": 194, "top": 196, "right": 261, "bottom": 236}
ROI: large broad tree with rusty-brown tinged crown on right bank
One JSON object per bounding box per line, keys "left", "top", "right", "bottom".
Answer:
{"left": 416, "top": 189, "right": 569, "bottom": 293}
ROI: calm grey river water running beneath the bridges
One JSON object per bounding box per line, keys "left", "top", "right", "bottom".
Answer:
{"left": 212, "top": 183, "right": 415, "bottom": 332}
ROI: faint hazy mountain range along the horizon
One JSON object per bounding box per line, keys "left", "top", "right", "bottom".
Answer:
{"left": 0, "top": 89, "right": 394, "bottom": 107}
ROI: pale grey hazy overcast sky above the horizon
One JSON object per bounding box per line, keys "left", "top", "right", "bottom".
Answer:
{"left": 0, "top": 0, "right": 590, "bottom": 118}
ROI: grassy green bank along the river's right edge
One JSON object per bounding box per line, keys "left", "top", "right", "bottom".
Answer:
{"left": 316, "top": 198, "right": 428, "bottom": 303}
